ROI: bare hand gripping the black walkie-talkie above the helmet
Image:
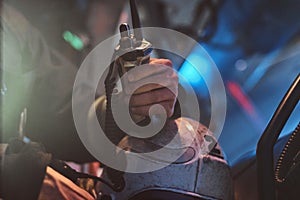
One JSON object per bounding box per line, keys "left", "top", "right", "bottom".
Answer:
{"left": 125, "top": 59, "right": 178, "bottom": 117}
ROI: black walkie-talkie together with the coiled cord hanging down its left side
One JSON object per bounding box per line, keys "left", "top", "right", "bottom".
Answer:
{"left": 105, "top": 0, "right": 152, "bottom": 191}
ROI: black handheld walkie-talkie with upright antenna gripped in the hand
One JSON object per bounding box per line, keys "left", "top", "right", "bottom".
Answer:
{"left": 106, "top": 0, "right": 152, "bottom": 131}
